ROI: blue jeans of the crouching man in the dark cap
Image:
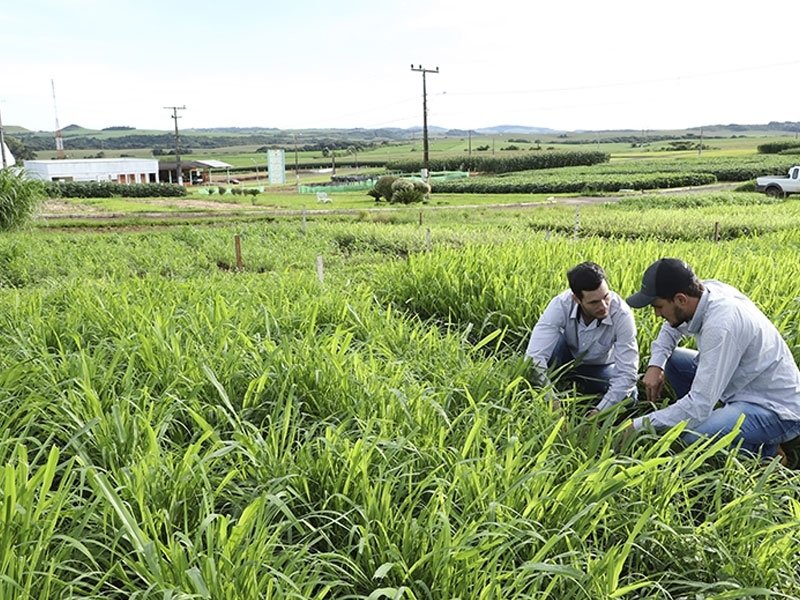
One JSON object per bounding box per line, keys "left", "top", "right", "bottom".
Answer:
{"left": 664, "top": 348, "right": 800, "bottom": 456}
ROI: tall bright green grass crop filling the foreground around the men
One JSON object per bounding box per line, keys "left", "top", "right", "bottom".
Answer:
{"left": 0, "top": 191, "right": 800, "bottom": 600}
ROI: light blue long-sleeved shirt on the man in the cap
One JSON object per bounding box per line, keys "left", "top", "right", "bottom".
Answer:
{"left": 633, "top": 280, "right": 800, "bottom": 429}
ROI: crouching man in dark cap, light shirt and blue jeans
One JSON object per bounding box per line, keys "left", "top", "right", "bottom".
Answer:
{"left": 627, "top": 258, "right": 800, "bottom": 456}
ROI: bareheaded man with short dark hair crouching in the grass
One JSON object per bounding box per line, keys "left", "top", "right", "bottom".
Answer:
{"left": 525, "top": 262, "right": 639, "bottom": 412}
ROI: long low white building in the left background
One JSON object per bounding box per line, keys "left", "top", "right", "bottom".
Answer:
{"left": 23, "top": 158, "right": 158, "bottom": 183}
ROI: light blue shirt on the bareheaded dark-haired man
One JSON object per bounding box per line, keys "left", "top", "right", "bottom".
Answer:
{"left": 525, "top": 290, "right": 639, "bottom": 410}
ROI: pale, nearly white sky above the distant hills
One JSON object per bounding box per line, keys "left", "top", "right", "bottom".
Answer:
{"left": 0, "top": 0, "right": 800, "bottom": 131}
